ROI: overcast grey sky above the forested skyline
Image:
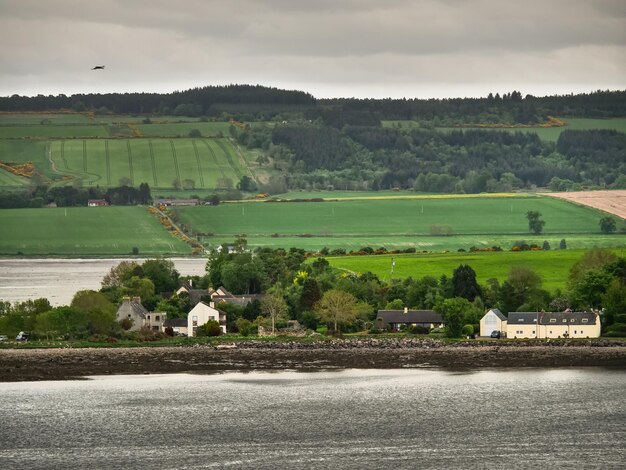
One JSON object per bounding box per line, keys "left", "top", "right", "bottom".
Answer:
{"left": 0, "top": 0, "right": 626, "bottom": 98}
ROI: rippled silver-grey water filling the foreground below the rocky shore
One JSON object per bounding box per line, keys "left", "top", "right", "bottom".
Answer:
{"left": 0, "top": 369, "right": 626, "bottom": 469}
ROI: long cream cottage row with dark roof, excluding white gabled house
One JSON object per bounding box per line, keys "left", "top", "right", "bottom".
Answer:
{"left": 506, "top": 311, "right": 600, "bottom": 338}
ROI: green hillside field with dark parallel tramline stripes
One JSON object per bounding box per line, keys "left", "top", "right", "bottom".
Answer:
{"left": 45, "top": 139, "right": 248, "bottom": 189}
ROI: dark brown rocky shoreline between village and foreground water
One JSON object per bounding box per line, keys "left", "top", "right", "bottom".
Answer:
{"left": 0, "top": 339, "right": 626, "bottom": 382}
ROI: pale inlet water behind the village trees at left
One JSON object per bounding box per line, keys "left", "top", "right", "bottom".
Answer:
{"left": 0, "top": 258, "right": 206, "bottom": 306}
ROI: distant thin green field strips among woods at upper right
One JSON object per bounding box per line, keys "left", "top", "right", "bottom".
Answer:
{"left": 383, "top": 118, "right": 626, "bottom": 142}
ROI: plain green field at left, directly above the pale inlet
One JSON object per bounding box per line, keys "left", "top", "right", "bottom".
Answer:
{"left": 0, "top": 207, "right": 191, "bottom": 256}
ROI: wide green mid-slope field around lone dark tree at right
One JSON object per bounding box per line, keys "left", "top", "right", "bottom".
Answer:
{"left": 175, "top": 196, "right": 626, "bottom": 251}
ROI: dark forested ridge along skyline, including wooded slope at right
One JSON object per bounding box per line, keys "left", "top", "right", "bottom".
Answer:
{"left": 0, "top": 85, "right": 626, "bottom": 193}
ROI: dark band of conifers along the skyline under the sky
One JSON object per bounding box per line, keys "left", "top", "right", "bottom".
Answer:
{"left": 0, "top": 85, "right": 626, "bottom": 123}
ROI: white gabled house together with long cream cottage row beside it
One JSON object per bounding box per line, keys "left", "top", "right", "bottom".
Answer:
{"left": 480, "top": 308, "right": 600, "bottom": 338}
